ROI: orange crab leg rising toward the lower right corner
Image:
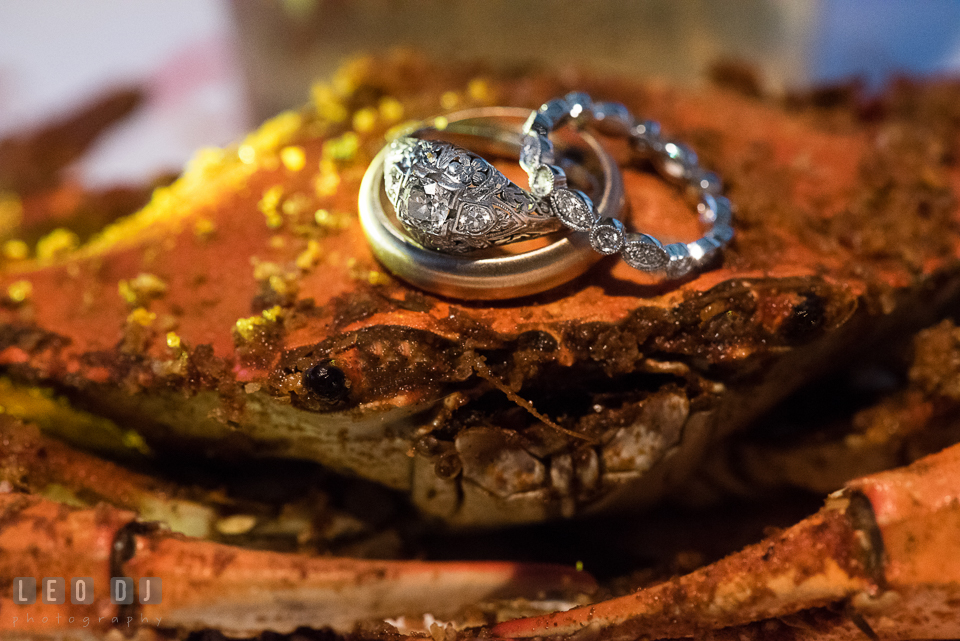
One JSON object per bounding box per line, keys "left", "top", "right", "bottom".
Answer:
{"left": 491, "top": 445, "right": 960, "bottom": 639}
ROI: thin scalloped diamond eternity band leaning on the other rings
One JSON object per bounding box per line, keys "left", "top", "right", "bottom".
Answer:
{"left": 520, "top": 92, "right": 733, "bottom": 278}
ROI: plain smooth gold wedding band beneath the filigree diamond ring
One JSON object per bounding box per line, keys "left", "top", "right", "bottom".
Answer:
{"left": 359, "top": 107, "right": 624, "bottom": 300}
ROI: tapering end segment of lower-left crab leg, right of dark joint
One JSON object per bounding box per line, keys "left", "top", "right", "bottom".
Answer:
{"left": 124, "top": 536, "right": 594, "bottom": 634}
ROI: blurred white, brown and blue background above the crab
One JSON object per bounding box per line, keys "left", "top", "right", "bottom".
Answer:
{"left": 0, "top": 0, "right": 960, "bottom": 187}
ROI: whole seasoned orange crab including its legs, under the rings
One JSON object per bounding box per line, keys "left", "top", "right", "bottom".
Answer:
{"left": 0, "top": 57, "right": 960, "bottom": 638}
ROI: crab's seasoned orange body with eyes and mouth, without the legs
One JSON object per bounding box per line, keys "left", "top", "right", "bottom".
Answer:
{"left": 0, "top": 57, "right": 960, "bottom": 525}
